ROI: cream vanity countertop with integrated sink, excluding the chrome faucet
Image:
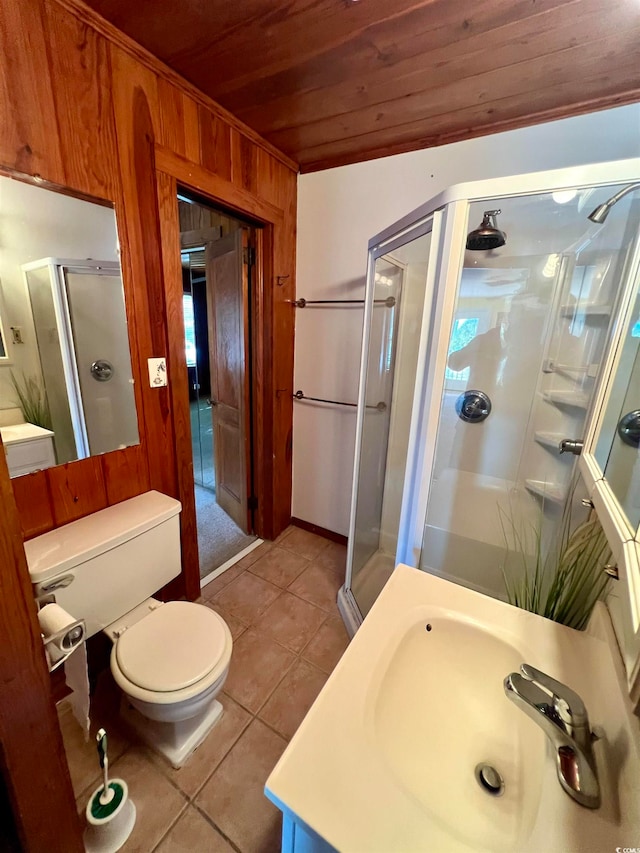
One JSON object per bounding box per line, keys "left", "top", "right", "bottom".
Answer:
{"left": 265, "top": 566, "right": 640, "bottom": 853}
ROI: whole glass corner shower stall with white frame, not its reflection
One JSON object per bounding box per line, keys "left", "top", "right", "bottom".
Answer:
{"left": 339, "top": 160, "right": 640, "bottom": 631}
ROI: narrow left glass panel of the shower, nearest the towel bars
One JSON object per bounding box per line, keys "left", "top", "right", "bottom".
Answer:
{"left": 346, "top": 221, "right": 432, "bottom": 616}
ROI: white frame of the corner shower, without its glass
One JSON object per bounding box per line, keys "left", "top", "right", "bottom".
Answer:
{"left": 338, "top": 158, "right": 640, "bottom": 632}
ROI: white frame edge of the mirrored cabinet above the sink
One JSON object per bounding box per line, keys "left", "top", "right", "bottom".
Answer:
{"left": 578, "top": 226, "right": 640, "bottom": 698}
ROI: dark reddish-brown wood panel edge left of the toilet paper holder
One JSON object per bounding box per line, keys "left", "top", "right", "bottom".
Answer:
{"left": 0, "top": 440, "right": 84, "bottom": 853}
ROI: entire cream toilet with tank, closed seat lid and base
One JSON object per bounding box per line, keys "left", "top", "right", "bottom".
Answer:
{"left": 25, "top": 492, "right": 233, "bottom": 767}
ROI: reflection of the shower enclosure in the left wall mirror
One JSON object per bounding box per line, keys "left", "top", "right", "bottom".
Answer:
{"left": 23, "top": 258, "right": 138, "bottom": 462}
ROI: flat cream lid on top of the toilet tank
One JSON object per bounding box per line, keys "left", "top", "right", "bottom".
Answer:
{"left": 24, "top": 492, "right": 182, "bottom": 584}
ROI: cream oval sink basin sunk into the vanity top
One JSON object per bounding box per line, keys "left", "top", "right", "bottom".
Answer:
{"left": 369, "top": 607, "right": 546, "bottom": 850}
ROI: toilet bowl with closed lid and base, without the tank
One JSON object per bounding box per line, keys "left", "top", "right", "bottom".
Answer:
{"left": 105, "top": 599, "right": 233, "bottom": 767}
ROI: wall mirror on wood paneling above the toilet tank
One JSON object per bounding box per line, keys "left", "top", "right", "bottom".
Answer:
{"left": 0, "top": 176, "right": 139, "bottom": 477}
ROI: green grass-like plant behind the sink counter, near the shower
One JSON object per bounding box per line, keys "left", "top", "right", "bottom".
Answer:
{"left": 499, "top": 482, "right": 611, "bottom": 631}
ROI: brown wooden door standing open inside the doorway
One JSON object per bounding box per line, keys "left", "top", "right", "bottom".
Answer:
{"left": 205, "top": 228, "right": 251, "bottom": 533}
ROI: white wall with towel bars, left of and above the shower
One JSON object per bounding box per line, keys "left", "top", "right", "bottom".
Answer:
{"left": 292, "top": 104, "right": 640, "bottom": 534}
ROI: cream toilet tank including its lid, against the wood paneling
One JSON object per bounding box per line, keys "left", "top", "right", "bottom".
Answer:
{"left": 24, "top": 492, "right": 182, "bottom": 637}
